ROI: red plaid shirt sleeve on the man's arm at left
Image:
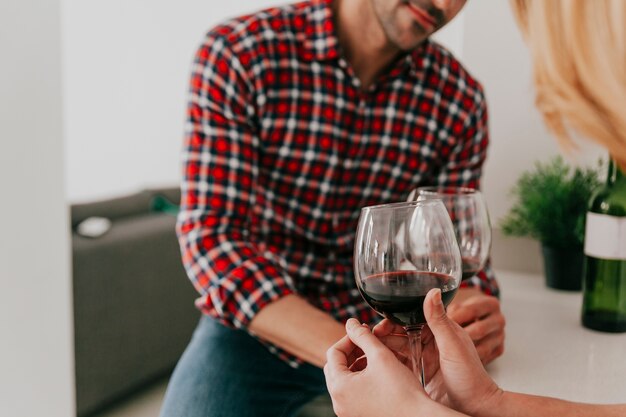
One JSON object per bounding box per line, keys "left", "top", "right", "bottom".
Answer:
{"left": 176, "top": 34, "right": 295, "bottom": 328}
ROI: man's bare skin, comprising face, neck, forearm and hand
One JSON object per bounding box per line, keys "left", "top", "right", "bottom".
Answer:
{"left": 250, "top": 0, "right": 504, "bottom": 367}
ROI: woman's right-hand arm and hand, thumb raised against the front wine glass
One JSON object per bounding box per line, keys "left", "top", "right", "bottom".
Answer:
{"left": 374, "top": 290, "right": 626, "bottom": 417}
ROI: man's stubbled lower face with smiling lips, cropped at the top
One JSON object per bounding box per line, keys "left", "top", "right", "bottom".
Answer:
{"left": 370, "top": 0, "right": 467, "bottom": 51}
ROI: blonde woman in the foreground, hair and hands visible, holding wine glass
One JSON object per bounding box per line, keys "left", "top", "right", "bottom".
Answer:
{"left": 324, "top": 0, "right": 626, "bottom": 417}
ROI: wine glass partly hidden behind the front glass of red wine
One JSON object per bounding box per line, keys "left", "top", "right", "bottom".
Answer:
{"left": 408, "top": 187, "right": 491, "bottom": 280}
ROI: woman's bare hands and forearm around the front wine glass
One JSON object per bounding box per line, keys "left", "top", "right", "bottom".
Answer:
{"left": 324, "top": 290, "right": 626, "bottom": 417}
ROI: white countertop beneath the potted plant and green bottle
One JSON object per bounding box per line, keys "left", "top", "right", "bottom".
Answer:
{"left": 487, "top": 271, "right": 626, "bottom": 403}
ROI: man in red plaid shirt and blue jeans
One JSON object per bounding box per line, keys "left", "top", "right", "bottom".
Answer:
{"left": 162, "top": 0, "right": 504, "bottom": 417}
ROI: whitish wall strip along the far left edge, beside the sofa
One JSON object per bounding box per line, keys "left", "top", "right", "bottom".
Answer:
{"left": 0, "top": 0, "right": 74, "bottom": 417}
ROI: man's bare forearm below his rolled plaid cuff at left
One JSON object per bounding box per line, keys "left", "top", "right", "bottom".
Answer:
{"left": 249, "top": 294, "right": 346, "bottom": 368}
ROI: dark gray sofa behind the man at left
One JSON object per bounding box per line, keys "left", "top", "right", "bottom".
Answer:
{"left": 71, "top": 189, "right": 199, "bottom": 416}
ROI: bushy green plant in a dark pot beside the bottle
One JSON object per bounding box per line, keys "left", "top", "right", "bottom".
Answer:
{"left": 500, "top": 157, "right": 600, "bottom": 291}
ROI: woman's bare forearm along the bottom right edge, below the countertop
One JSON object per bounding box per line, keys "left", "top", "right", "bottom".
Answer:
{"left": 477, "top": 392, "right": 626, "bottom": 417}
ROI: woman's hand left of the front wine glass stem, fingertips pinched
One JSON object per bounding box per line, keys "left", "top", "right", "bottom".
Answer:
{"left": 324, "top": 319, "right": 438, "bottom": 417}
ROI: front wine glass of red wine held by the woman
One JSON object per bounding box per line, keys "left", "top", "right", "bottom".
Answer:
{"left": 354, "top": 200, "right": 461, "bottom": 385}
